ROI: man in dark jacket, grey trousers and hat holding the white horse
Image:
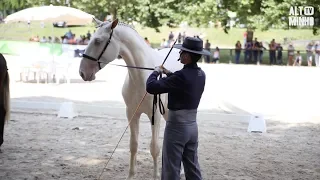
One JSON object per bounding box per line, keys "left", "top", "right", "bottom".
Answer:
{"left": 146, "top": 37, "right": 211, "bottom": 180}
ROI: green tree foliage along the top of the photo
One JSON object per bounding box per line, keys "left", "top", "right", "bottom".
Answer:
{"left": 0, "top": 0, "right": 320, "bottom": 34}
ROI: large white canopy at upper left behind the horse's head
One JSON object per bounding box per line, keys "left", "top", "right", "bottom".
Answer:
{"left": 4, "top": 5, "right": 94, "bottom": 25}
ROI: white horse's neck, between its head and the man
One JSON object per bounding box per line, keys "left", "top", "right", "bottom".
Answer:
{"left": 120, "top": 28, "right": 157, "bottom": 83}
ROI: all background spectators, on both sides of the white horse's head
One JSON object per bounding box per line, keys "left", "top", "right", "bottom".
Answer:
{"left": 30, "top": 30, "right": 320, "bottom": 66}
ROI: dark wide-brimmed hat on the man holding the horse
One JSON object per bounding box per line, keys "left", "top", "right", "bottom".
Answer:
{"left": 173, "top": 37, "right": 211, "bottom": 56}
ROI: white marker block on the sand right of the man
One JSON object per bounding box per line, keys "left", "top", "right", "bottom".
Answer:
{"left": 248, "top": 114, "right": 267, "bottom": 133}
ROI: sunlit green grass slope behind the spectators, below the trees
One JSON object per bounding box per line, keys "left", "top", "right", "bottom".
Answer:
{"left": 0, "top": 23, "right": 320, "bottom": 49}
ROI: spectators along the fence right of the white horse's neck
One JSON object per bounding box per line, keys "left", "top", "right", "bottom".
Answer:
{"left": 160, "top": 32, "right": 320, "bottom": 66}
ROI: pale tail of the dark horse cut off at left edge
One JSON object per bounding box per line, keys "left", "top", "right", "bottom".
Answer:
{"left": 3, "top": 71, "right": 10, "bottom": 123}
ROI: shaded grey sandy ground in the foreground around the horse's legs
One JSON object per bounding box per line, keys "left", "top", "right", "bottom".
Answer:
{"left": 0, "top": 108, "right": 320, "bottom": 180}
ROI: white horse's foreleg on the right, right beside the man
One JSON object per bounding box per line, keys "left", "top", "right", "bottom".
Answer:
{"left": 148, "top": 112, "right": 161, "bottom": 179}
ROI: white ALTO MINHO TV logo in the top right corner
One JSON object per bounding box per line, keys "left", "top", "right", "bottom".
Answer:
{"left": 289, "top": 6, "right": 314, "bottom": 27}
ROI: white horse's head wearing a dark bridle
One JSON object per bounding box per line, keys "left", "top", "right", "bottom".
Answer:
{"left": 79, "top": 19, "right": 120, "bottom": 81}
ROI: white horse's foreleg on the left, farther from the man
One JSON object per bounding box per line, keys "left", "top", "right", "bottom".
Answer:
{"left": 127, "top": 107, "right": 141, "bottom": 180}
